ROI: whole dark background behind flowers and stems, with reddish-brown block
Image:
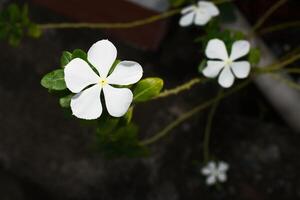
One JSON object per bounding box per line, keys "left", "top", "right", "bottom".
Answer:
{"left": 0, "top": 0, "right": 300, "bottom": 200}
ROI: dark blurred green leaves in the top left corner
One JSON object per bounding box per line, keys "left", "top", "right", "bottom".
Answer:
{"left": 0, "top": 4, "right": 42, "bottom": 46}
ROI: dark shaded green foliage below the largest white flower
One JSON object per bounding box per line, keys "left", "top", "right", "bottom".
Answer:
{"left": 97, "top": 122, "right": 148, "bottom": 158}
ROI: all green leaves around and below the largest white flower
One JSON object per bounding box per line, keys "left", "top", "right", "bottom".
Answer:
{"left": 41, "top": 49, "right": 163, "bottom": 158}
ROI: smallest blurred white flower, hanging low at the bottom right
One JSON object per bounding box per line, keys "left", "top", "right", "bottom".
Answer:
{"left": 201, "top": 161, "right": 229, "bottom": 185}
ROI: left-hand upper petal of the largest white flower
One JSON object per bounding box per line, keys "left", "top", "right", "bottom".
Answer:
{"left": 64, "top": 58, "right": 100, "bottom": 93}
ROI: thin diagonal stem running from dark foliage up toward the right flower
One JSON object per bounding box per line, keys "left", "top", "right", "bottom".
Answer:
{"left": 140, "top": 79, "right": 250, "bottom": 145}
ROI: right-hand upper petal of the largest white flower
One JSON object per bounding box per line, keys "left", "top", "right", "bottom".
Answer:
{"left": 107, "top": 61, "right": 143, "bottom": 85}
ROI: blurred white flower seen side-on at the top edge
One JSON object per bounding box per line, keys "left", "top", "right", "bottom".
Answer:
{"left": 179, "top": 1, "right": 220, "bottom": 26}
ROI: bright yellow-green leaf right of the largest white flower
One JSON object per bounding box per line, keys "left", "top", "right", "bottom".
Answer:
{"left": 133, "top": 78, "right": 164, "bottom": 102}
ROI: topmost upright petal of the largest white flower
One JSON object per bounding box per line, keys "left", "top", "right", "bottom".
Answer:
{"left": 88, "top": 40, "right": 117, "bottom": 78}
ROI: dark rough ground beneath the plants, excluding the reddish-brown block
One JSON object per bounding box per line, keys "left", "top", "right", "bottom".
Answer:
{"left": 0, "top": 0, "right": 300, "bottom": 200}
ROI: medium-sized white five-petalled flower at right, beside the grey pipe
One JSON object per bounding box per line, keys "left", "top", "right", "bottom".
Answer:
{"left": 202, "top": 39, "right": 251, "bottom": 88}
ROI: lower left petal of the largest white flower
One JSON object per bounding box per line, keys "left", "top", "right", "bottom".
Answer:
{"left": 71, "top": 84, "right": 102, "bottom": 120}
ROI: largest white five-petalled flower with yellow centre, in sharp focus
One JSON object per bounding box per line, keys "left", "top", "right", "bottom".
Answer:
{"left": 64, "top": 40, "right": 143, "bottom": 120}
